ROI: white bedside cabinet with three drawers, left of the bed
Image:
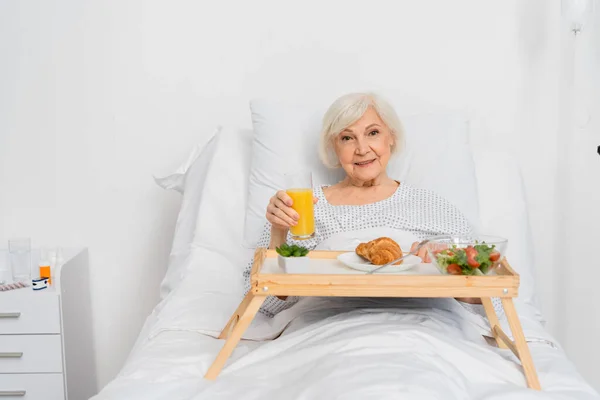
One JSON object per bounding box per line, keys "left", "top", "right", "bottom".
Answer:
{"left": 0, "top": 249, "right": 97, "bottom": 400}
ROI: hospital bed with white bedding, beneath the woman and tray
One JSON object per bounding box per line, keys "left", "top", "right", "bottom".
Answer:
{"left": 93, "top": 104, "right": 600, "bottom": 400}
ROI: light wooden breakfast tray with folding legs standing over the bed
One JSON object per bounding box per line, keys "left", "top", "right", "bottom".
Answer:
{"left": 205, "top": 248, "right": 540, "bottom": 390}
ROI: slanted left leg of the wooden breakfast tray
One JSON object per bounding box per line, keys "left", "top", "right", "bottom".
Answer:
{"left": 204, "top": 292, "right": 267, "bottom": 380}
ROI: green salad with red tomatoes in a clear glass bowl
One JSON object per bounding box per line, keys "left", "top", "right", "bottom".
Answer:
{"left": 433, "top": 243, "right": 500, "bottom": 275}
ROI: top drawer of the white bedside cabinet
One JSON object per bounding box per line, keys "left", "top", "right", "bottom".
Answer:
{"left": 0, "top": 289, "right": 60, "bottom": 335}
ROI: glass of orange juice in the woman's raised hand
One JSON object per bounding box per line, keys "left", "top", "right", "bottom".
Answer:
{"left": 285, "top": 171, "right": 315, "bottom": 240}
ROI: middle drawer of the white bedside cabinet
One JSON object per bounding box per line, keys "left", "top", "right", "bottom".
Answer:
{"left": 0, "top": 335, "right": 62, "bottom": 372}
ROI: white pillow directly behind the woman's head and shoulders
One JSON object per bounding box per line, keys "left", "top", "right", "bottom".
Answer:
{"left": 244, "top": 99, "right": 480, "bottom": 248}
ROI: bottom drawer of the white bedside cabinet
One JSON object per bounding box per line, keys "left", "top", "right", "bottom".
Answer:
{"left": 0, "top": 374, "right": 65, "bottom": 400}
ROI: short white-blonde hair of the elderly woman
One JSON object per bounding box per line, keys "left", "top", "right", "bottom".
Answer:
{"left": 319, "top": 93, "right": 404, "bottom": 168}
